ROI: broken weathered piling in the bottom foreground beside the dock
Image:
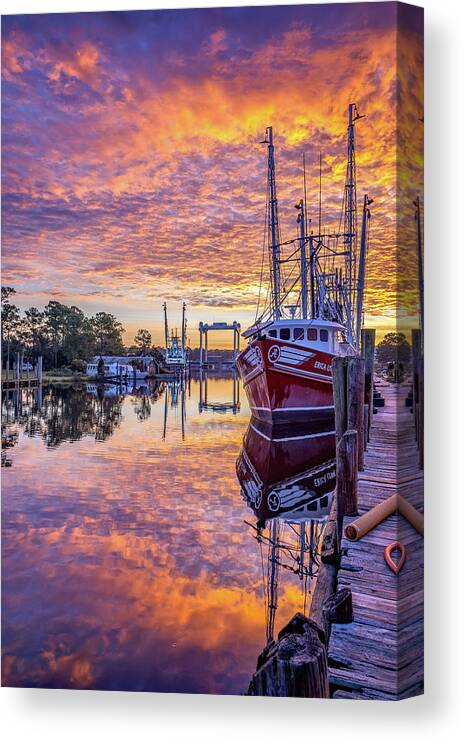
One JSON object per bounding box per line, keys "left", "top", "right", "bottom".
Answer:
{"left": 247, "top": 613, "right": 329, "bottom": 698}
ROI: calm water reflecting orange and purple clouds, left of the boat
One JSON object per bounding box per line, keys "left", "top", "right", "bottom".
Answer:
{"left": 2, "top": 378, "right": 328, "bottom": 693}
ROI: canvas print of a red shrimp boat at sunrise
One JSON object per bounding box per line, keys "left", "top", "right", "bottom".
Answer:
{"left": 1, "top": 2, "right": 424, "bottom": 700}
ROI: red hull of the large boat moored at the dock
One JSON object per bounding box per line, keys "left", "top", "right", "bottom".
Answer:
{"left": 237, "top": 338, "right": 334, "bottom": 424}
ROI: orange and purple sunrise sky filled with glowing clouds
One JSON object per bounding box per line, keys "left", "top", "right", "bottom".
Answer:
{"left": 2, "top": 2, "right": 423, "bottom": 347}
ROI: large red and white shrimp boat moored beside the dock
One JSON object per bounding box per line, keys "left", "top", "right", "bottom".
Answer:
{"left": 237, "top": 103, "right": 372, "bottom": 424}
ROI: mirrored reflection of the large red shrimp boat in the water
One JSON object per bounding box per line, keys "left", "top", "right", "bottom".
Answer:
{"left": 236, "top": 410, "right": 336, "bottom": 641}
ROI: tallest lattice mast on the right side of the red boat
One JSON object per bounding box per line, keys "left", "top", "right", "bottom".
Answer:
{"left": 344, "top": 103, "right": 364, "bottom": 343}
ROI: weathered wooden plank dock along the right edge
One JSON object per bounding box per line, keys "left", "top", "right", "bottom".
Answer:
{"left": 328, "top": 380, "right": 423, "bottom": 700}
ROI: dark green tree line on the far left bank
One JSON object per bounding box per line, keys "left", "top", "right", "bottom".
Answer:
{"left": 1, "top": 286, "right": 161, "bottom": 371}
